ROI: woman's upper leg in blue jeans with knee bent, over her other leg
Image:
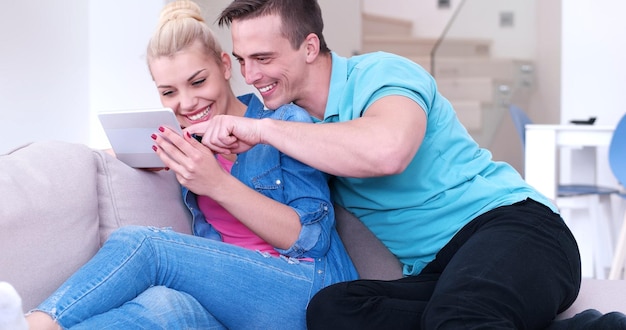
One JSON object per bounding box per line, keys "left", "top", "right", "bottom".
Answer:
{"left": 37, "top": 226, "right": 323, "bottom": 329}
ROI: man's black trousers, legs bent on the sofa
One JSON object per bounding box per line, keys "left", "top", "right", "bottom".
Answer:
{"left": 307, "top": 200, "right": 581, "bottom": 330}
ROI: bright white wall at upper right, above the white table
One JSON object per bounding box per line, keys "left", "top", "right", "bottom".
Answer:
{"left": 561, "top": 0, "right": 626, "bottom": 125}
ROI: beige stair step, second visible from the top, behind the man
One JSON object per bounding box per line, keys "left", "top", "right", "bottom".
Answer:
{"left": 362, "top": 34, "right": 491, "bottom": 57}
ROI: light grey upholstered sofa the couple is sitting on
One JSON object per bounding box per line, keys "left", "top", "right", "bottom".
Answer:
{"left": 0, "top": 141, "right": 626, "bottom": 317}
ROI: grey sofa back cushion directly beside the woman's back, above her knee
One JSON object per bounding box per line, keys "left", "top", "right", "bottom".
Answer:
{"left": 94, "top": 150, "right": 191, "bottom": 243}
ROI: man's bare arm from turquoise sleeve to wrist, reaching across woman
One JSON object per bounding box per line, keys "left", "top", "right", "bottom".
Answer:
{"left": 259, "top": 96, "right": 426, "bottom": 177}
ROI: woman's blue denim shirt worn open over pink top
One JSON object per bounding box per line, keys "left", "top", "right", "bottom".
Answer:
{"left": 183, "top": 94, "right": 352, "bottom": 268}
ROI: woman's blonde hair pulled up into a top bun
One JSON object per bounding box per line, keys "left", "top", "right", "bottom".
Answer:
{"left": 147, "top": 0, "right": 222, "bottom": 63}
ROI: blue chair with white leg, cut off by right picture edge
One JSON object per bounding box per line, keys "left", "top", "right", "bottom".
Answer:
{"left": 609, "top": 114, "right": 626, "bottom": 280}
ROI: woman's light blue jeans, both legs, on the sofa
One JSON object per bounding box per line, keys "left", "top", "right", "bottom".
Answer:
{"left": 36, "top": 226, "right": 353, "bottom": 329}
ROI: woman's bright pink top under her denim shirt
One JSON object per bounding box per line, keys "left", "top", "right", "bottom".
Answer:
{"left": 198, "top": 155, "right": 279, "bottom": 256}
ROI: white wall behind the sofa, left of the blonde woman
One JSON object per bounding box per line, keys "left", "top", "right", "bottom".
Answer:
{"left": 0, "top": 0, "right": 164, "bottom": 153}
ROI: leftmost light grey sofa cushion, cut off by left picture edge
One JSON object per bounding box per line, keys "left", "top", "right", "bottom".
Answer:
{"left": 0, "top": 141, "right": 100, "bottom": 309}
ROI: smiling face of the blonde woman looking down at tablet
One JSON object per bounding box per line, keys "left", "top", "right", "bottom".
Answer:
{"left": 149, "top": 42, "right": 232, "bottom": 127}
